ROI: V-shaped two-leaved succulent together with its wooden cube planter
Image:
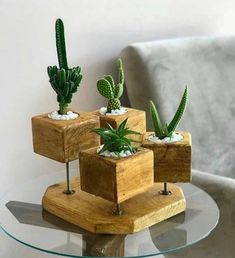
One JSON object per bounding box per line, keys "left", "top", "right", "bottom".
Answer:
{"left": 143, "top": 87, "right": 192, "bottom": 194}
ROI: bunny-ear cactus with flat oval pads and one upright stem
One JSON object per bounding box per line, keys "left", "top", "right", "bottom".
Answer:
{"left": 97, "top": 58, "right": 124, "bottom": 113}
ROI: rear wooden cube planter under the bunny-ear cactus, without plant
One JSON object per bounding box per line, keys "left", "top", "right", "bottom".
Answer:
{"left": 91, "top": 108, "right": 146, "bottom": 143}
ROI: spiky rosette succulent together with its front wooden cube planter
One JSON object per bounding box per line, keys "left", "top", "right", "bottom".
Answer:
{"left": 79, "top": 119, "right": 154, "bottom": 214}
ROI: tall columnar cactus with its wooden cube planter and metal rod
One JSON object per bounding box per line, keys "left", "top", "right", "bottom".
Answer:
{"left": 32, "top": 19, "right": 100, "bottom": 194}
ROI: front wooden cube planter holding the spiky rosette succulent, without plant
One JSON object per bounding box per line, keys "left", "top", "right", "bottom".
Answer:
{"left": 79, "top": 148, "right": 153, "bottom": 203}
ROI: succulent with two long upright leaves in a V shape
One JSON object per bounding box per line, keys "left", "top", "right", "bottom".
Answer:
{"left": 150, "top": 86, "right": 188, "bottom": 139}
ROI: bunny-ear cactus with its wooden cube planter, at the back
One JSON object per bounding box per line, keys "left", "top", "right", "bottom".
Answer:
{"left": 94, "top": 58, "right": 146, "bottom": 141}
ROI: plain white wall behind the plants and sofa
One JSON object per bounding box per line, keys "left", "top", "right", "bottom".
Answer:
{"left": 0, "top": 0, "right": 235, "bottom": 257}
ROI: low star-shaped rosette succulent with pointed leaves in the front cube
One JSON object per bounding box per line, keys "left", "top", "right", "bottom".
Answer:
{"left": 93, "top": 118, "right": 140, "bottom": 156}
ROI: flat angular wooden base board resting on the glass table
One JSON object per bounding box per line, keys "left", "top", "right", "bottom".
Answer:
{"left": 42, "top": 178, "right": 186, "bottom": 234}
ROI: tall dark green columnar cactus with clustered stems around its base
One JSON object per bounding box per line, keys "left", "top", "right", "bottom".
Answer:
{"left": 47, "top": 19, "right": 82, "bottom": 115}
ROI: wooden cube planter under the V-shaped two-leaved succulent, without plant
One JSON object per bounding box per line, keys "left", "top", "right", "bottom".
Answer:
{"left": 143, "top": 132, "right": 192, "bottom": 182}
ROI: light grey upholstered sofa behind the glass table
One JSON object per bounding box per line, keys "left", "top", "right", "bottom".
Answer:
{"left": 121, "top": 37, "right": 235, "bottom": 258}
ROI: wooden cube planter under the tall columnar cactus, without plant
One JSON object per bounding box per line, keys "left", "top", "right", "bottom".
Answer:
{"left": 32, "top": 112, "right": 100, "bottom": 163}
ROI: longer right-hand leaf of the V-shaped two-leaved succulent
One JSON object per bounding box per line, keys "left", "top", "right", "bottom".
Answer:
{"left": 167, "top": 86, "right": 188, "bottom": 132}
